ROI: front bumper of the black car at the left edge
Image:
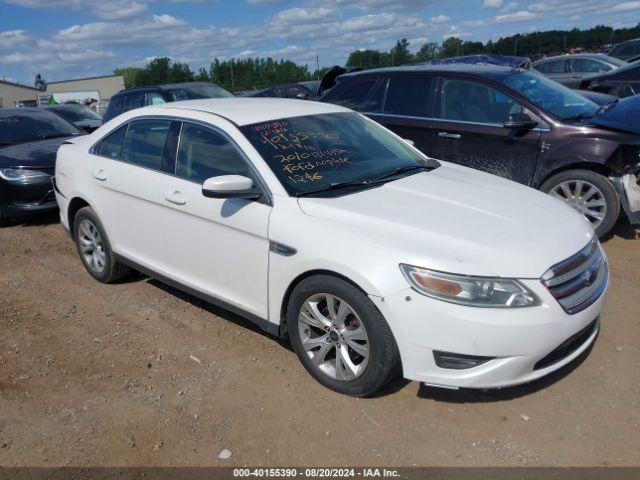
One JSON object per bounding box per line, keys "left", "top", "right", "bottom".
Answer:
{"left": 0, "top": 178, "right": 58, "bottom": 219}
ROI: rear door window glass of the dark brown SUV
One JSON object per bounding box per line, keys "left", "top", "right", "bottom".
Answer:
{"left": 384, "top": 77, "right": 431, "bottom": 117}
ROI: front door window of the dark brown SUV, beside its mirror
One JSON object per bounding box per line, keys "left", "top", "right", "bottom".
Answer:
{"left": 440, "top": 79, "right": 523, "bottom": 124}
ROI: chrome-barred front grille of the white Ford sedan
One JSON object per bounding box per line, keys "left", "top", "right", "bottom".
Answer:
{"left": 542, "top": 238, "right": 609, "bottom": 315}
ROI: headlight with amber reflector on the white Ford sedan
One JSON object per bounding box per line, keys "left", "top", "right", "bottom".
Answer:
{"left": 400, "top": 264, "right": 539, "bottom": 308}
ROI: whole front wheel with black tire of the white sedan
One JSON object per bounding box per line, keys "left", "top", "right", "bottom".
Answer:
{"left": 286, "top": 275, "right": 400, "bottom": 397}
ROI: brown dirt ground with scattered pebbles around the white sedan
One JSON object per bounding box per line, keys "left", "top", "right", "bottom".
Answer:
{"left": 0, "top": 217, "right": 640, "bottom": 466}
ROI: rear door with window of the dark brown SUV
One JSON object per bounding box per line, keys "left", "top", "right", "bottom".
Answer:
{"left": 363, "top": 75, "right": 436, "bottom": 156}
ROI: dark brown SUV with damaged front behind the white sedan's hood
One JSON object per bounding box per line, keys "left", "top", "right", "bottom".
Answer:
{"left": 322, "top": 65, "right": 640, "bottom": 236}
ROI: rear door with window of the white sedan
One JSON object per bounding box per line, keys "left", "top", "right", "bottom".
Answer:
{"left": 91, "top": 119, "right": 175, "bottom": 273}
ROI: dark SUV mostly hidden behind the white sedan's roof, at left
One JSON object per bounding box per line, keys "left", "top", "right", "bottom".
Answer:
{"left": 103, "top": 82, "right": 234, "bottom": 122}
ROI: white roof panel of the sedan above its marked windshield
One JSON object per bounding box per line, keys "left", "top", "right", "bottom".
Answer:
{"left": 152, "top": 97, "right": 351, "bottom": 126}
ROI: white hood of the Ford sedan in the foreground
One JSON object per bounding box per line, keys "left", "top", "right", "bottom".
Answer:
{"left": 299, "top": 162, "right": 594, "bottom": 278}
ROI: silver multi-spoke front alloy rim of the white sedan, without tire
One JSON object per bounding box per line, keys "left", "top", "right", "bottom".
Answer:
{"left": 298, "top": 293, "right": 370, "bottom": 381}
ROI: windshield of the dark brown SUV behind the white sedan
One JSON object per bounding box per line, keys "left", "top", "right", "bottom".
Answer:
{"left": 502, "top": 72, "right": 598, "bottom": 120}
